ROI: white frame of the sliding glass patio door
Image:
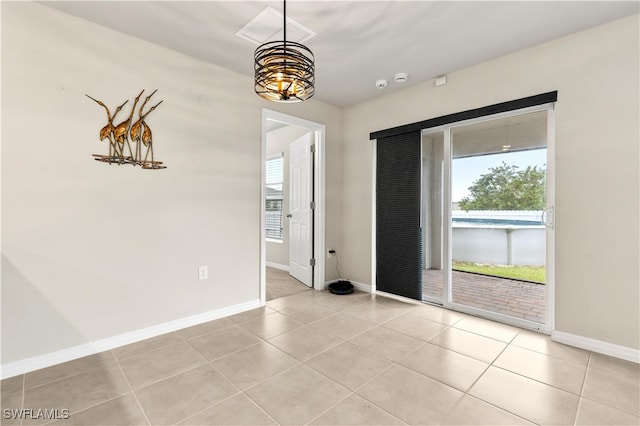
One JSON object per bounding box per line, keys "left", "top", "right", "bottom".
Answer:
{"left": 371, "top": 101, "right": 555, "bottom": 334}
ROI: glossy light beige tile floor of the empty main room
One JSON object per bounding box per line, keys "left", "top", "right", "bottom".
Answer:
{"left": 1, "top": 291, "right": 640, "bottom": 425}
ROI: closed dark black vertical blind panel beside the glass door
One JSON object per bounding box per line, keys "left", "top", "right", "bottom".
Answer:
{"left": 376, "top": 131, "right": 422, "bottom": 300}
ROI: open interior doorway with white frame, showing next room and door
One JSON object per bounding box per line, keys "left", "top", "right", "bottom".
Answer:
{"left": 260, "top": 109, "right": 325, "bottom": 305}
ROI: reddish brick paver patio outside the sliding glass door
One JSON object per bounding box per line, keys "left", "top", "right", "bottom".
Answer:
{"left": 422, "top": 269, "right": 546, "bottom": 324}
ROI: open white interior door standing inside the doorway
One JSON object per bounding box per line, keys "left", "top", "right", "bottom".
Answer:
{"left": 287, "top": 133, "right": 313, "bottom": 287}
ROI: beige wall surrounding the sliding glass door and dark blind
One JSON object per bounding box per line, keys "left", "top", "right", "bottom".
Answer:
{"left": 342, "top": 15, "right": 640, "bottom": 350}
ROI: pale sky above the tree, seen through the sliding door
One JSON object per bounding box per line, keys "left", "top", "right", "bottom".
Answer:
{"left": 451, "top": 149, "right": 547, "bottom": 202}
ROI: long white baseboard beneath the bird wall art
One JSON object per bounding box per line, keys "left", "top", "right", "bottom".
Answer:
{"left": 0, "top": 299, "right": 260, "bottom": 379}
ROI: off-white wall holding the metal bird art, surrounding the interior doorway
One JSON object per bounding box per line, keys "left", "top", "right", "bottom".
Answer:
{"left": 2, "top": 2, "right": 341, "bottom": 365}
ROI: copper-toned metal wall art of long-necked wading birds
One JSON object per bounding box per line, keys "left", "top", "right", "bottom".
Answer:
{"left": 85, "top": 89, "right": 167, "bottom": 169}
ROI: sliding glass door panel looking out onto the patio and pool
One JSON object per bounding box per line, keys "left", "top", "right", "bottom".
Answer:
{"left": 421, "top": 106, "right": 553, "bottom": 329}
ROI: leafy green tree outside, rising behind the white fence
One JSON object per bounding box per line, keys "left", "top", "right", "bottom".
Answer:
{"left": 459, "top": 161, "right": 546, "bottom": 211}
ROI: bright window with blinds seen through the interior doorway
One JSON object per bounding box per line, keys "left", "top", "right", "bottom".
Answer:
{"left": 265, "top": 153, "right": 284, "bottom": 240}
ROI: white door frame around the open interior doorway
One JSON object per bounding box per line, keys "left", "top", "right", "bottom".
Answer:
{"left": 260, "top": 108, "right": 326, "bottom": 306}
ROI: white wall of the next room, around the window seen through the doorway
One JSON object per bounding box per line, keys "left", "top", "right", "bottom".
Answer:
{"left": 266, "top": 126, "right": 309, "bottom": 267}
